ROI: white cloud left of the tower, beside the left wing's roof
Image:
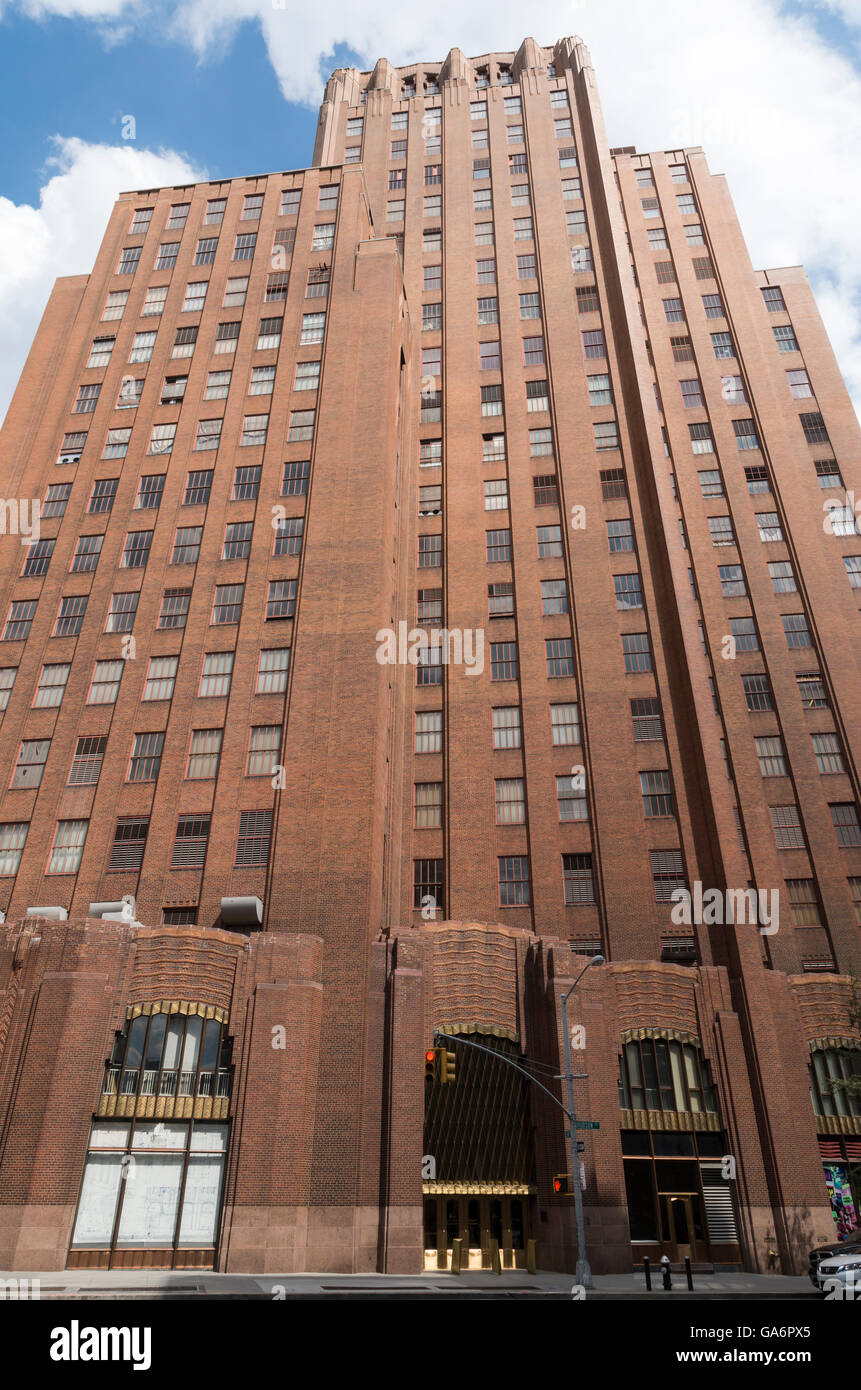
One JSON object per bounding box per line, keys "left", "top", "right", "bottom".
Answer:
{"left": 0, "top": 136, "right": 206, "bottom": 428}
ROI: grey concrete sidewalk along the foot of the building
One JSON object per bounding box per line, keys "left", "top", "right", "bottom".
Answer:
{"left": 0, "top": 1269, "right": 819, "bottom": 1302}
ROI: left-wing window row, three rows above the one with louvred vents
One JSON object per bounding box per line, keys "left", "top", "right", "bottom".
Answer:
{"left": 0, "top": 580, "right": 296, "bottom": 653}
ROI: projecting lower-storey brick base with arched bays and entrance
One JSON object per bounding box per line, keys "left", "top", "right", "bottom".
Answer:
{"left": 0, "top": 919, "right": 861, "bottom": 1275}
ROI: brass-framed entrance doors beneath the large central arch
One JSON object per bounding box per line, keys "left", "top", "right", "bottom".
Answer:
{"left": 424, "top": 1194, "right": 529, "bottom": 1269}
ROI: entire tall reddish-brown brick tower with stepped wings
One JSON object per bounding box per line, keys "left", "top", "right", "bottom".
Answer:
{"left": 0, "top": 29, "right": 861, "bottom": 1272}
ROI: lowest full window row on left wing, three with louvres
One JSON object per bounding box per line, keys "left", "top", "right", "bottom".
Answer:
{"left": 0, "top": 810, "right": 273, "bottom": 878}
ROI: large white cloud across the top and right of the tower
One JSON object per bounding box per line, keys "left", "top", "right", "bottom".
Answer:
{"left": 1, "top": 0, "right": 861, "bottom": 419}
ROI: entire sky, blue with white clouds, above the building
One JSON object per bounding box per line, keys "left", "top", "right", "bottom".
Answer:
{"left": 0, "top": 0, "right": 861, "bottom": 417}
